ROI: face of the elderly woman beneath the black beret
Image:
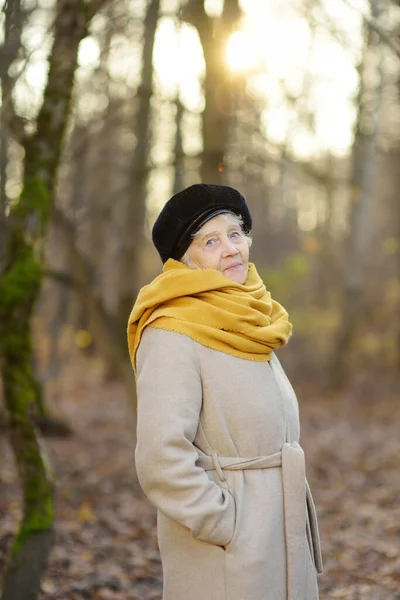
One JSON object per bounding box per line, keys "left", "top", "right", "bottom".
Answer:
{"left": 185, "top": 214, "right": 249, "bottom": 284}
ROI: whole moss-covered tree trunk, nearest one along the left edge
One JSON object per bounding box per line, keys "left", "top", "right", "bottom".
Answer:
{"left": 0, "top": 0, "right": 92, "bottom": 600}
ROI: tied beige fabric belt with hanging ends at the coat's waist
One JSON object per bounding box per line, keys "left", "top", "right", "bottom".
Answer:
{"left": 197, "top": 442, "right": 322, "bottom": 600}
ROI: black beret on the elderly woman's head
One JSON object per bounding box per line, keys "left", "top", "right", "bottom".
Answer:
{"left": 152, "top": 183, "right": 252, "bottom": 263}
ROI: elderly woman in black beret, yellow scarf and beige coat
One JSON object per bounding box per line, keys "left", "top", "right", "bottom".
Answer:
{"left": 128, "top": 184, "right": 322, "bottom": 600}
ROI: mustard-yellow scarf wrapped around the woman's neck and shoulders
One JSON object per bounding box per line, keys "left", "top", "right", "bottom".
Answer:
{"left": 128, "top": 258, "right": 292, "bottom": 372}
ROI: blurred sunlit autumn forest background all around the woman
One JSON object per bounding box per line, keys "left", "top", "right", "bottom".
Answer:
{"left": 0, "top": 0, "right": 400, "bottom": 600}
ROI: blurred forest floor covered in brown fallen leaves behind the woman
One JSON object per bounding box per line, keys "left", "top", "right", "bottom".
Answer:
{"left": 0, "top": 374, "right": 400, "bottom": 600}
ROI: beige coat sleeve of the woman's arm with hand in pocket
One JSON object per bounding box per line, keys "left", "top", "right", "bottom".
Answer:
{"left": 135, "top": 327, "right": 236, "bottom": 546}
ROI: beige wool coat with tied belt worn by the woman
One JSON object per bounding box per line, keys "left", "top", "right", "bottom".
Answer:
{"left": 136, "top": 327, "right": 321, "bottom": 600}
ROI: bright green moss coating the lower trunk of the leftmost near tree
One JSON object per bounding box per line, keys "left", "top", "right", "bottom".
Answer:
{"left": 0, "top": 203, "right": 54, "bottom": 568}
